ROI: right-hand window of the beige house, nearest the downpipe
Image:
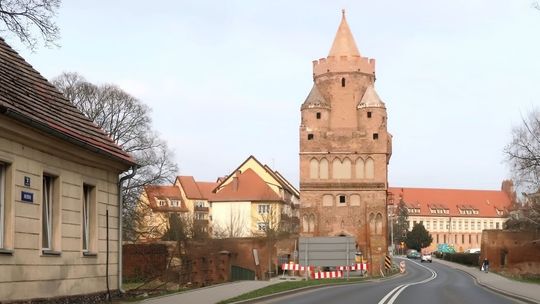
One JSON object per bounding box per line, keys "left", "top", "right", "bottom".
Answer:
{"left": 82, "top": 185, "right": 96, "bottom": 252}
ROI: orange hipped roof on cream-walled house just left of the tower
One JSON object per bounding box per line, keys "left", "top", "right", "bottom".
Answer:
{"left": 210, "top": 168, "right": 282, "bottom": 202}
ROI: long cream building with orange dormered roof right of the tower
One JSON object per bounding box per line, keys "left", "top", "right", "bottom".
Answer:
{"left": 388, "top": 181, "right": 515, "bottom": 252}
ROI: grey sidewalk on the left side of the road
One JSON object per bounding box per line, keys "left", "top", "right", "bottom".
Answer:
{"left": 133, "top": 280, "right": 280, "bottom": 304}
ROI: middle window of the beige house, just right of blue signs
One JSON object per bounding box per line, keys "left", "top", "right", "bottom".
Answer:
{"left": 41, "top": 175, "right": 60, "bottom": 251}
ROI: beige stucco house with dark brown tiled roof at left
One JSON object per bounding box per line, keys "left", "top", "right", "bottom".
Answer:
{"left": 0, "top": 38, "right": 135, "bottom": 302}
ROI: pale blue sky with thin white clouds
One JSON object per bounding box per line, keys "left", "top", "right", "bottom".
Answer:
{"left": 6, "top": 0, "right": 540, "bottom": 190}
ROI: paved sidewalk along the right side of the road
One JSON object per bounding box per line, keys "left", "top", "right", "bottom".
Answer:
{"left": 434, "top": 259, "right": 540, "bottom": 303}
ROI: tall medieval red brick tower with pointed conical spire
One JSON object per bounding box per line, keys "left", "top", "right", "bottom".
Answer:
{"left": 300, "top": 11, "right": 392, "bottom": 272}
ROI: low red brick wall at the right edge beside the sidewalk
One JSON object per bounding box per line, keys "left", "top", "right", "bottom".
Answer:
{"left": 480, "top": 230, "right": 540, "bottom": 276}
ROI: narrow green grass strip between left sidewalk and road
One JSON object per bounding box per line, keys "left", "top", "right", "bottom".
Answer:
{"left": 218, "top": 278, "right": 365, "bottom": 304}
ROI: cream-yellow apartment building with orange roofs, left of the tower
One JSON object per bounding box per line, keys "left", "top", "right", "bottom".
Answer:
{"left": 139, "top": 156, "right": 299, "bottom": 240}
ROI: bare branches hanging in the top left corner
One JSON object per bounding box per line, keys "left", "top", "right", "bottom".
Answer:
{"left": 0, "top": 0, "right": 60, "bottom": 50}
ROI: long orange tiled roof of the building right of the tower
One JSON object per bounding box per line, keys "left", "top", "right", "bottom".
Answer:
{"left": 388, "top": 187, "right": 512, "bottom": 217}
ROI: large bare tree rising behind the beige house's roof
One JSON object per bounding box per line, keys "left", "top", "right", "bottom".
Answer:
{"left": 52, "top": 73, "right": 178, "bottom": 240}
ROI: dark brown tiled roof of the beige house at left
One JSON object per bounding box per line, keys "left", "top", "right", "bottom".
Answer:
{"left": 0, "top": 38, "right": 135, "bottom": 165}
